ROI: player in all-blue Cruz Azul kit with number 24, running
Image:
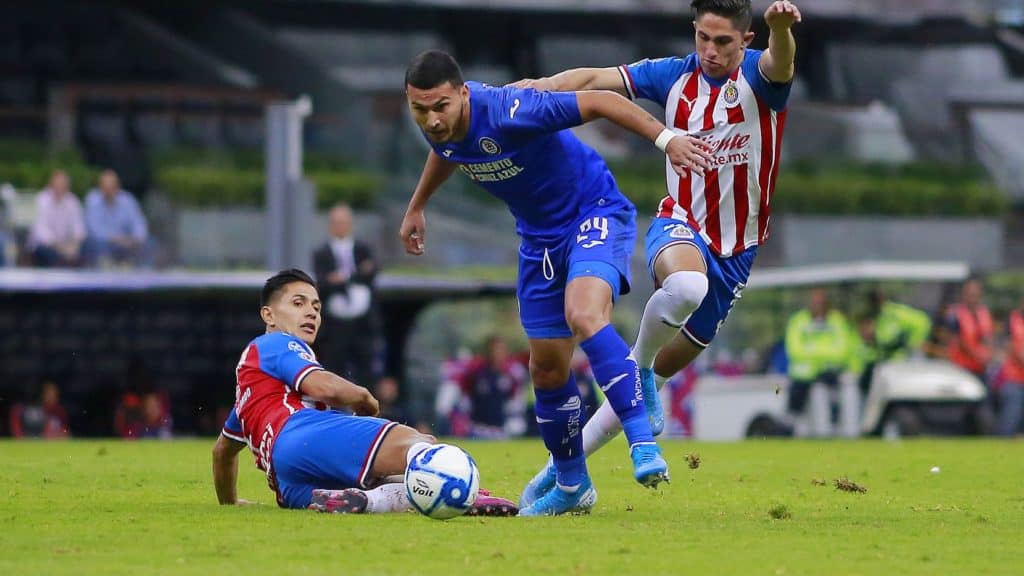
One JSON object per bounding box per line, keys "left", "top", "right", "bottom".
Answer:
{"left": 399, "top": 50, "right": 702, "bottom": 516}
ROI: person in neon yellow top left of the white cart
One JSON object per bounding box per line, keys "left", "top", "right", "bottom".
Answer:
{"left": 785, "top": 288, "right": 861, "bottom": 436}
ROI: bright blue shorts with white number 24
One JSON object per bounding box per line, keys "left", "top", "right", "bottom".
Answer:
{"left": 516, "top": 205, "right": 636, "bottom": 338}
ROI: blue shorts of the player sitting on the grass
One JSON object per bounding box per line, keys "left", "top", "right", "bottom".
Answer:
{"left": 270, "top": 409, "right": 397, "bottom": 508}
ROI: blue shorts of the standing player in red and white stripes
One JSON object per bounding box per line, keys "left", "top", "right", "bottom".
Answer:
{"left": 644, "top": 218, "right": 757, "bottom": 348}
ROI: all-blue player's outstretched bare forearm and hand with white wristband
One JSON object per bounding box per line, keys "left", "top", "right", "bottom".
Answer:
{"left": 577, "top": 90, "right": 712, "bottom": 174}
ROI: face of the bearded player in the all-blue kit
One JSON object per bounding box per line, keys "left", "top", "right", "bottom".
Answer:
{"left": 406, "top": 82, "right": 469, "bottom": 143}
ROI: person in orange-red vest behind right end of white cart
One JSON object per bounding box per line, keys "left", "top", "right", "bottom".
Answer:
{"left": 945, "top": 278, "right": 995, "bottom": 383}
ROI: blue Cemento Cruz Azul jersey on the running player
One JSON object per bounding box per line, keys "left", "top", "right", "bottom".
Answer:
{"left": 428, "top": 82, "right": 631, "bottom": 241}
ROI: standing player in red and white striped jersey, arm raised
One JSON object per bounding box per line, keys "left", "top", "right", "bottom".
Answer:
{"left": 516, "top": 0, "right": 801, "bottom": 457}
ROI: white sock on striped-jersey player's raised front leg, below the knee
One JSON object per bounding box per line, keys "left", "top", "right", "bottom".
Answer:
{"left": 633, "top": 271, "right": 708, "bottom": 368}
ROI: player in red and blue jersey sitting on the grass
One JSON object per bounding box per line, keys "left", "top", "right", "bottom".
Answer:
{"left": 213, "top": 270, "right": 516, "bottom": 516}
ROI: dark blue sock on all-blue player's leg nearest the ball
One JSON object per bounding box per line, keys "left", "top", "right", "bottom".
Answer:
{"left": 534, "top": 372, "right": 587, "bottom": 486}
